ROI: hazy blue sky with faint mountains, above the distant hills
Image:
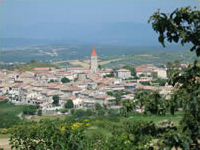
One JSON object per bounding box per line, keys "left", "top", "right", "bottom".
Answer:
{"left": 0, "top": 0, "right": 200, "bottom": 43}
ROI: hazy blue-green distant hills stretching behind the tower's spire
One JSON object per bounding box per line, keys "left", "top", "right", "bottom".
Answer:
{"left": 1, "top": 45, "right": 193, "bottom": 63}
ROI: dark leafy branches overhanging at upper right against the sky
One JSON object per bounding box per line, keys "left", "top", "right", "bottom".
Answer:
{"left": 148, "top": 7, "right": 200, "bottom": 56}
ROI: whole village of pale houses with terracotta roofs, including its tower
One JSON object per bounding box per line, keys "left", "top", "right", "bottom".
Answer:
{"left": 0, "top": 46, "right": 172, "bottom": 110}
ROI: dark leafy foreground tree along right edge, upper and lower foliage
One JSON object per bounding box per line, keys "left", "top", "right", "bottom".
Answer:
{"left": 149, "top": 7, "right": 200, "bottom": 150}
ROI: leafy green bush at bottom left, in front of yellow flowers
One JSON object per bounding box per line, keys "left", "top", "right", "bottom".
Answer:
{"left": 10, "top": 120, "right": 85, "bottom": 150}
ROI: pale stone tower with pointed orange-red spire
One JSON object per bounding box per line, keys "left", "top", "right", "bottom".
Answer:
{"left": 90, "top": 46, "right": 98, "bottom": 73}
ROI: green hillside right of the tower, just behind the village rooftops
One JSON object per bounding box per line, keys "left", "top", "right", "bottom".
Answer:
{"left": 102, "top": 50, "right": 197, "bottom": 68}
